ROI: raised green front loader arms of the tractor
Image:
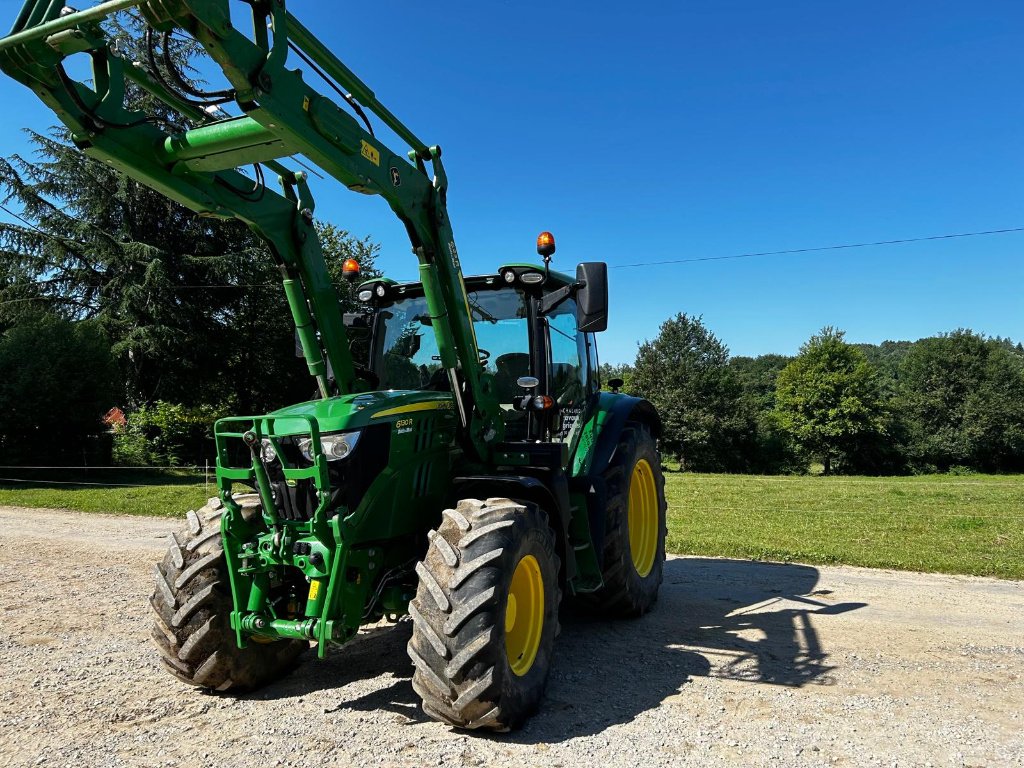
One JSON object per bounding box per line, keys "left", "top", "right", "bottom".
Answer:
{"left": 0, "top": 0, "right": 504, "bottom": 459}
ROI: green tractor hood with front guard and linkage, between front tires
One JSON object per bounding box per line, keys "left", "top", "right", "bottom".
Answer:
{"left": 215, "top": 391, "right": 460, "bottom": 654}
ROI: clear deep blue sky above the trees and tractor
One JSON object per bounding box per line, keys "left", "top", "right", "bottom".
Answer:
{"left": 0, "top": 0, "right": 1024, "bottom": 362}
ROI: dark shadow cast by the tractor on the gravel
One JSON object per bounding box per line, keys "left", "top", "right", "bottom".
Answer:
{"left": 251, "top": 557, "right": 864, "bottom": 743}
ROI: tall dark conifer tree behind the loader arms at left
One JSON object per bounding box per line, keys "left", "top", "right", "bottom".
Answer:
{"left": 0, "top": 14, "right": 378, "bottom": 412}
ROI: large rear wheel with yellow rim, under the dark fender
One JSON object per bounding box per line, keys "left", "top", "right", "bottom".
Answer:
{"left": 581, "top": 422, "right": 668, "bottom": 616}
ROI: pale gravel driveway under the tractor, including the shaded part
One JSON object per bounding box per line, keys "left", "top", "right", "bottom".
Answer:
{"left": 0, "top": 507, "right": 1024, "bottom": 768}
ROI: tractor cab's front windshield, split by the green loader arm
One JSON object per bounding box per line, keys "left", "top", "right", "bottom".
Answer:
{"left": 373, "top": 287, "right": 529, "bottom": 402}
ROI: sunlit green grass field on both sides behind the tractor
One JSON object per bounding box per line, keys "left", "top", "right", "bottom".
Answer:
{"left": 0, "top": 470, "right": 1024, "bottom": 579}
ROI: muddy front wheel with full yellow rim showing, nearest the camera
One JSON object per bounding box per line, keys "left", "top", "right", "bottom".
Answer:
{"left": 409, "top": 499, "right": 561, "bottom": 731}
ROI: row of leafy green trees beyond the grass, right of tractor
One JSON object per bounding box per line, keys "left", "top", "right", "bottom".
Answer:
{"left": 602, "top": 314, "right": 1024, "bottom": 474}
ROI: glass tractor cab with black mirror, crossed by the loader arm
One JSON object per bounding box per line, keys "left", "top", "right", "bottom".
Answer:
{"left": 350, "top": 252, "right": 607, "bottom": 441}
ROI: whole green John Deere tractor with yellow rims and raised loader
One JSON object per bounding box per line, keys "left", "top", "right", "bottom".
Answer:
{"left": 0, "top": 0, "right": 666, "bottom": 730}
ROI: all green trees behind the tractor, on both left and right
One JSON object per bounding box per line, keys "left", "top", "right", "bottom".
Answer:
{"left": 0, "top": 120, "right": 1024, "bottom": 474}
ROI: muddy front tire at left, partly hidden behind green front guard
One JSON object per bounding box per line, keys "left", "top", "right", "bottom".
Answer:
{"left": 150, "top": 494, "right": 308, "bottom": 692}
